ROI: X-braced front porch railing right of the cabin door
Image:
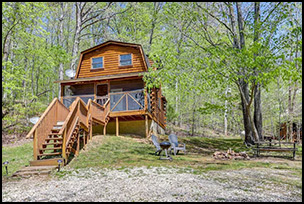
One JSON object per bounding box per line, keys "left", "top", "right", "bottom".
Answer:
{"left": 110, "top": 89, "right": 145, "bottom": 112}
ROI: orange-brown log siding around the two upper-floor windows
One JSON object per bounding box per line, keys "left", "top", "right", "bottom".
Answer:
{"left": 76, "top": 44, "right": 146, "bottom": 78}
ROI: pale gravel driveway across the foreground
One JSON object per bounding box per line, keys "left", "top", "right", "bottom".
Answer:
{"left": 2, "top": 167, "right": 302, "bottom": 202}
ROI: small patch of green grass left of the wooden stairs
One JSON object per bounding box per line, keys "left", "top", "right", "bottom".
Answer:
{"left": 2, "top": 142, "right": 33, "bottom": 177}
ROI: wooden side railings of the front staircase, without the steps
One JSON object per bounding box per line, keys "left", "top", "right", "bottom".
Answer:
{"left": 26, "top": 97, "right": 110, "bottom": 161}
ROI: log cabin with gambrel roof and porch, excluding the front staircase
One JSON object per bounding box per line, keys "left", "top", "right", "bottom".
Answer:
{"left": 56, "top": 41, "right": 166, "bottom": 137}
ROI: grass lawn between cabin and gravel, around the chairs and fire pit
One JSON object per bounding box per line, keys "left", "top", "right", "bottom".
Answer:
{"left": 69, "top": 136, "right": 302, "bottom": 174}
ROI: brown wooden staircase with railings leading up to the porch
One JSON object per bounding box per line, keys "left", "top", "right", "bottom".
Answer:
{"left": 26, "top": 97, "right": 110, "bottom": 172}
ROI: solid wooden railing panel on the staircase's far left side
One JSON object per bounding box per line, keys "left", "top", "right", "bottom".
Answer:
{"left": 25, "top": 98, "right": 69, "bottom": 160}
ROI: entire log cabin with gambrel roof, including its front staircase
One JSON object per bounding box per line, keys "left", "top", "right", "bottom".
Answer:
{"left": 26, "top": 41, "right": 166, "bottom": 166}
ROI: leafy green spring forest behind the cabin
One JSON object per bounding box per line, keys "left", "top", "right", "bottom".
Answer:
{"left": 2, "top": 2, "right": 302, "bottom": 144}
